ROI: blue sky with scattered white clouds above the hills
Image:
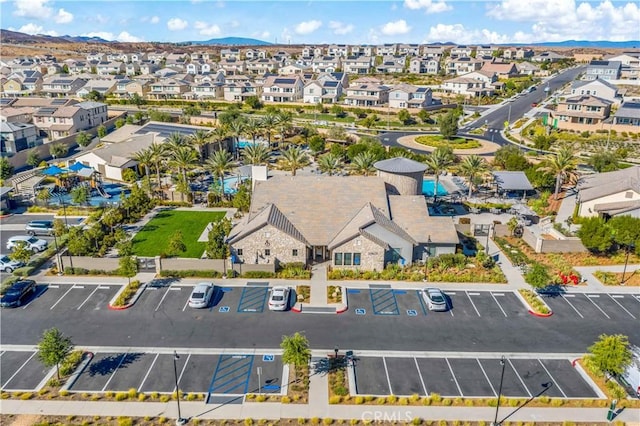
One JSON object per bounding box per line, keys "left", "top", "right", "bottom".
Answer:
{"left": 0, "top": 0, "right": 640, "bottom": 44}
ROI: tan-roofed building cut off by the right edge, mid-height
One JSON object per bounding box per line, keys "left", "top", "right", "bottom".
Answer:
{"left": 576, "top": 166, "right": 640, "bottom": 217}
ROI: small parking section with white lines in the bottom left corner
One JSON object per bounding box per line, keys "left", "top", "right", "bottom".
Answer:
{"left": 0, "top": 351, "right": 55, "bottom": 392}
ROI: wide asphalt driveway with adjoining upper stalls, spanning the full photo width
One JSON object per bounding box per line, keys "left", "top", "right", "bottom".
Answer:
{"left": 0, "top": 284, "right": 640, "bottom": 353}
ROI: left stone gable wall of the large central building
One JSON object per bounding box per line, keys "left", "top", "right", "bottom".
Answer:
{"left": 231, "top": 225, "right": 307, "bottom": 264}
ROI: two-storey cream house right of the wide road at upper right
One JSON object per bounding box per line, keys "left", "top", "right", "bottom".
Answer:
{"left": 551, "top": 95, "right": 612, "bottom": 132}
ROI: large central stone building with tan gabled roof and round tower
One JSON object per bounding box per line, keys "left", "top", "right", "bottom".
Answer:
{"left": 227, "top": 158, "right": 459, "bottom": 271}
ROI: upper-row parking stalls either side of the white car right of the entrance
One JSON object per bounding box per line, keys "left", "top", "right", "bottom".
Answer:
{"left": 347, "top": 285, "right": 528, "bottom": 320}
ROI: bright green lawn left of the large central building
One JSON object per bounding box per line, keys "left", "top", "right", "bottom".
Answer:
{"left": 133, "top": 210, "right": 224, "bottom": 258}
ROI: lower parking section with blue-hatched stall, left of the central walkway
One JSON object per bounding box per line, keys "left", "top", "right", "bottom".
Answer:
{"left": 69, "top": 350, "right": 287, "bottom": 403}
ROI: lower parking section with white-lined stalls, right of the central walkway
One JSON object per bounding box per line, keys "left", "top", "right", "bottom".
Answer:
{"left": 352, "top": 354, "right": 598, "bottom": 398}
